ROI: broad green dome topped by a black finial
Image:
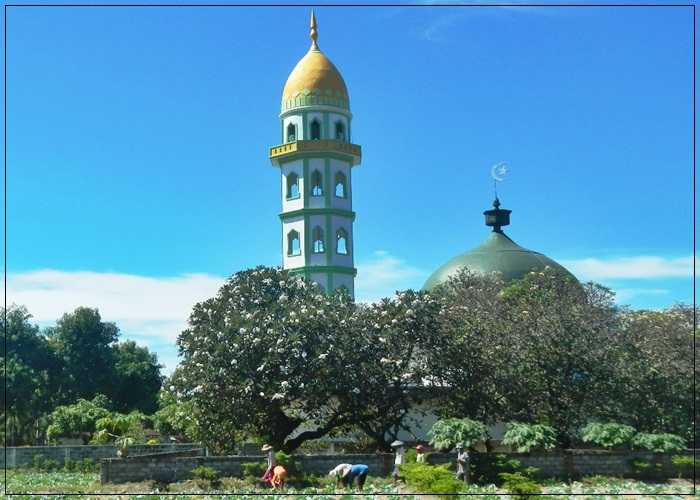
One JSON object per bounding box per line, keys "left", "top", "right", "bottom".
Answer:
{"left": 423, "top": 200, "right": 576, "bottom": 290}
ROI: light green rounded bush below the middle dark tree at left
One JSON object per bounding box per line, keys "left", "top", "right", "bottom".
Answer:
{"left": 46, "top": 394, "right": 110, "bottom": 444}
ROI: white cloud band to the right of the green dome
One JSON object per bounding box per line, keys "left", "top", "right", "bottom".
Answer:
{"left": 559, "top": 256, "right": 693, "bottom": 280}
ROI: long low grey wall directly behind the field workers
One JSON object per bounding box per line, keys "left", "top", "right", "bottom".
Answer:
{"left": 100, "top": 450, "right": 692, "bottom": 483}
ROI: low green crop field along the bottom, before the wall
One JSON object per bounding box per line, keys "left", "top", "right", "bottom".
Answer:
{"left": 0, "top": 470, "right": 693, "bottom": 500}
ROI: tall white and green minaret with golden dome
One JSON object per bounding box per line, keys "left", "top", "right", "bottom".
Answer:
{"left": 270, "top": 11, "right": 361, "bottom": 296}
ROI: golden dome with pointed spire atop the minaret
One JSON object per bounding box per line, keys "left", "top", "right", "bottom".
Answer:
{"left": 282, "top": 11, "right": 350, "bottom": 111}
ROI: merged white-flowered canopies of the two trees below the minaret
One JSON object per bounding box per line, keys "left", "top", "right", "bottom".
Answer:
{"left": 169, "top": 267, "right": 437, "bottom": 451}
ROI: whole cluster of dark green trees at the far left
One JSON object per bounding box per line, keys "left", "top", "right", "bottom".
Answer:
{"left": 0, "top": 305, "right": 160, "bottom": 445}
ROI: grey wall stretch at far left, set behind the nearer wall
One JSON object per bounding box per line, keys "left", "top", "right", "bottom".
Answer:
{"left": 0, "top": 443, "right": 200, "bottom": 469}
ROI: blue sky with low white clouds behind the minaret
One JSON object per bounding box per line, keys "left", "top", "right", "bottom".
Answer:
{"left": 7, "top": 1, "right": 693, "bottom": 369}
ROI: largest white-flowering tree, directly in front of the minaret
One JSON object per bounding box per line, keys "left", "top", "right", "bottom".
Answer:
{"left": 173, "top": 266, "right": 358, "bottom": 451}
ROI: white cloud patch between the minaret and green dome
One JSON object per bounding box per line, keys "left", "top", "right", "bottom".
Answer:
{"left": 355, "top": 250, "right": 428, "bottom": 302}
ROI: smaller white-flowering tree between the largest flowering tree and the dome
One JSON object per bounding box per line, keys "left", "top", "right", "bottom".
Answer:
{"left": 344, "top": 290, "right": 441, "bottom": 451}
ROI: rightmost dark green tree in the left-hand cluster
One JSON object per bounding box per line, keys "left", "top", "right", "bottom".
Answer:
{"left": 110, "top": 340, "right": 163, "bottom": 414}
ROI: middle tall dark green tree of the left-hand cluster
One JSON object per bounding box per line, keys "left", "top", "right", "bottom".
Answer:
{"left": 47, "top": 307, "right": 119, "bottom": 400}
